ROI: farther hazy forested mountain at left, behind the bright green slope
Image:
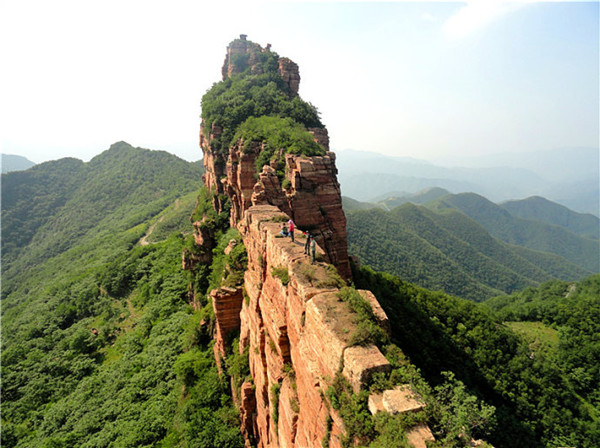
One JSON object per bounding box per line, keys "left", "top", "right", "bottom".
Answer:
{"left": 2, "top": 142, "right": 201, "bottom": 291}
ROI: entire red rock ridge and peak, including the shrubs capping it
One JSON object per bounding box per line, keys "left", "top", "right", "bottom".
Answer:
{"left": 184, "top": 35, "right": 432, "bottom": 447}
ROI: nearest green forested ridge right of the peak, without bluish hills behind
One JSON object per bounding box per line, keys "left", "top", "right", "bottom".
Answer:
{"left": 347, "top": 203, "right": 592, "bottom": 301}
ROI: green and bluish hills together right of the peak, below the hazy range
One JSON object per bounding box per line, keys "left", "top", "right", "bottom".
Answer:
{"left": 343, "top": 188, "right": 600, "bottom": 301}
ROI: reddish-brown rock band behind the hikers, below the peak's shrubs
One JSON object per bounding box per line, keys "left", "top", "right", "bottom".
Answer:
{"left": 200, "top": 114, "right": 351, "bottom": 278}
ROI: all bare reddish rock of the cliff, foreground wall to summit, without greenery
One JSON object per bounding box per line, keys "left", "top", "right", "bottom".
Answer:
{"left": 198, "top": 36, "right": 431, "bottom": 447}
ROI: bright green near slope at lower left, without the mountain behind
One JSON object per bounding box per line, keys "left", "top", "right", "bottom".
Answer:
{"left": 2, "top": 236, "right": 243, "bottom": 447}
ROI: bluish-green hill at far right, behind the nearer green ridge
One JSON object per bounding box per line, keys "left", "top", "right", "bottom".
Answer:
{"left": 428, "top": 193, "right": 600, "bottom": 272}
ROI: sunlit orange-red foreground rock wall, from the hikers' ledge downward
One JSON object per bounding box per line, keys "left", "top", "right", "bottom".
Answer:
{"left": 232, "top": 205, "right": 390, "bottom": 447}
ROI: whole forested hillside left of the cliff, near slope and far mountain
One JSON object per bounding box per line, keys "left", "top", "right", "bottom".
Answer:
{"left": 1, "top": 143, "right": 243, "bottom": 448}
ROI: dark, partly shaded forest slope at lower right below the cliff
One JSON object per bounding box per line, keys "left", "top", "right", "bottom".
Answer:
{"left": 353, "top": 267, "right": 600, "bottom": 448}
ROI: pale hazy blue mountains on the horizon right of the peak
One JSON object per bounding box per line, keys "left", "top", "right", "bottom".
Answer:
{"left": 337, "top": 148, "right": 600, "bottom": 216}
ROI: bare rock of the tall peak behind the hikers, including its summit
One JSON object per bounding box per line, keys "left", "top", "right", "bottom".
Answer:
{"left": 200, "top": 35, "right": 351, "bottom": 279}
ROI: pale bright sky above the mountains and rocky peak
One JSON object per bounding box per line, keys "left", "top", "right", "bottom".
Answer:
{"left": 0, "top": 0, "right": 600, "bottom": 163}
